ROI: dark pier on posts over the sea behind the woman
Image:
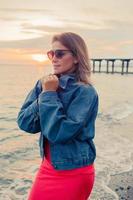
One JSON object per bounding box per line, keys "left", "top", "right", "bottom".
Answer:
{"left": 91, "top": 58, "right": 133, "bottom": 75}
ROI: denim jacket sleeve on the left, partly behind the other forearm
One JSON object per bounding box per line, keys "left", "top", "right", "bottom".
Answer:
{"left": 17, "top": 80, "right": 42, "bottom": 133}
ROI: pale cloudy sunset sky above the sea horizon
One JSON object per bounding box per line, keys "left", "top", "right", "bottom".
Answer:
{"left": 0, "top": 0, "right": 133, "bottom": 65}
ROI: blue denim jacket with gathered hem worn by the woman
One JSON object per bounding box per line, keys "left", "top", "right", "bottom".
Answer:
{"left": 17, "top": 73, "right": 98, "bottom": 170}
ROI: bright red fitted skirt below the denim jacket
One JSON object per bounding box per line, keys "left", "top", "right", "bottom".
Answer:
{"left": 28, "top": 139, "right": 95, "bottom": 200}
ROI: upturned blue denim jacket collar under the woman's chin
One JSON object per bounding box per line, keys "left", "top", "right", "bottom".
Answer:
{"left": 58, "top": 73, "right": 76, "bottom": 89}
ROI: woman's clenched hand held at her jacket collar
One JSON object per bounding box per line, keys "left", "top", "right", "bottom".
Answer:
{"left": 40, "top": 74, "right": 59, "bottom": 91}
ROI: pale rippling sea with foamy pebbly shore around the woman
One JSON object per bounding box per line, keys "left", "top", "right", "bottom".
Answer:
{"left": 0, "top": 65, "right": 133, "bottom": 200}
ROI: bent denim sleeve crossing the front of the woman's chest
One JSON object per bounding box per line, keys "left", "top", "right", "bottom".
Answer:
{"left": 38, "top": 86, "right": 98, "bottom": 143}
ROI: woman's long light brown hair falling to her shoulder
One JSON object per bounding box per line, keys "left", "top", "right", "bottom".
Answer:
{"left": 52, "top": 32, "right": 92, "bottom": 85}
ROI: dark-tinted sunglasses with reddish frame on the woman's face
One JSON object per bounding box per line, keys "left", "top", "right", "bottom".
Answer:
{"left": 47, "top": 49, "right": 73, "bottom": 60}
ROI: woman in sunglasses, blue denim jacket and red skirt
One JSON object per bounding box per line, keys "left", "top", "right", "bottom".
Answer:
{"left": 17, "top": 32, "right": 98, "bottom": 200}
